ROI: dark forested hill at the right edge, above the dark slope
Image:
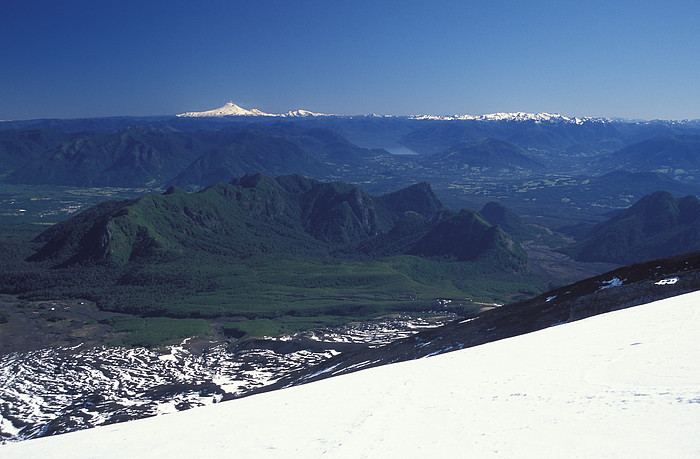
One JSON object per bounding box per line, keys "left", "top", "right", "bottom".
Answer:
{"left": 569, "top": 191, "right": 700, "bottom": 264}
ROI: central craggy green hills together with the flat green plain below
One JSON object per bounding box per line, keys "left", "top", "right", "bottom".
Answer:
{"left": 0, "top": 175, "right": 545, "bottom": 344}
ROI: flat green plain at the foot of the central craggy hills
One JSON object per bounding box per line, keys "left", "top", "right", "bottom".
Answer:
{"left": 0, "top": 250, "right": 543, "bottom": 319}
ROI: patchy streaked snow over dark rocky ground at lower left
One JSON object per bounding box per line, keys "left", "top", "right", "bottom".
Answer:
{"left": 0, "top": 315, "right": 454, "bottom": 441}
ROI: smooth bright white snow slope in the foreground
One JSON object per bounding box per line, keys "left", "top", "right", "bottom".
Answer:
{"left": 0, "top": 292, "right": 700, "bottom": 458}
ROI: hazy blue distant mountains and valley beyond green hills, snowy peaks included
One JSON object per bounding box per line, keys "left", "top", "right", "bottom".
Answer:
{"left": 0, "top": 108, "right": 700, "bottom": 244}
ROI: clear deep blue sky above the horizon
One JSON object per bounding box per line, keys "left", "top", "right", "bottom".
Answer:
{"left": 0, "top": 0, "right": 700, "bottom": 119}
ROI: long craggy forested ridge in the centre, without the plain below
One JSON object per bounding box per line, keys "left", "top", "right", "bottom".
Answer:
{"left": 30, "top": 174, "right": 526, "bottom": 271}
